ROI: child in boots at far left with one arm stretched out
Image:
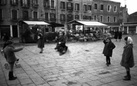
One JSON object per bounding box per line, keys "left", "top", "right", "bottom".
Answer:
{"left": 3, "top": 40, "right": 23, "bottom": 80}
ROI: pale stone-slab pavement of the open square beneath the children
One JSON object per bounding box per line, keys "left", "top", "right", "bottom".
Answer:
{"left": 0, "top": 36, "right": 137, "bottom": 86}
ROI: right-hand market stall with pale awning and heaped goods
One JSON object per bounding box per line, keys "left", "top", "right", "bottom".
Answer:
{"left": 68, "top": 20, "right": 108, "bottom": 41}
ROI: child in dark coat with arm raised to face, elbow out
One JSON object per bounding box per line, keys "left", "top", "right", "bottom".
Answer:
{"left": 103, "top": 37, "right": 115, "bottom": 66}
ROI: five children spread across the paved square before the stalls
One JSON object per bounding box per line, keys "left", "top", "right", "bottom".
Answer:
{"left": 0, "top": 29, "right": 134, "bottom": 80}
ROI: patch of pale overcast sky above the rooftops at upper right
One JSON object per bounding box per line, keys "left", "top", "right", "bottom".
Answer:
{"left": 112, "top": 0, "right": 137, "bottom": 14}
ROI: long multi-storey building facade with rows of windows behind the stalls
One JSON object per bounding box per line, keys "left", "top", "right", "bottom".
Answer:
{"left": 0, "top": 0, "right": 120, "bottom": 38}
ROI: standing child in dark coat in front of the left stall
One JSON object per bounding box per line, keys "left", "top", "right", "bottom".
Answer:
{"left": 38, "top": 29, "right": 44, "bottom": 53}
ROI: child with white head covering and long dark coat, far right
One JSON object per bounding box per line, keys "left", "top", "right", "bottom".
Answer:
{"left": 120, "top": 37, "right": 135, "bottom": 80}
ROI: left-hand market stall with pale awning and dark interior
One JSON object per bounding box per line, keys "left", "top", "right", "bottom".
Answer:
{"left": 19, "top": 21, "right": 49, "bottom": 43}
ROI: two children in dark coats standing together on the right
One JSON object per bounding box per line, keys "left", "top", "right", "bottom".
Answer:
{"left": 103, "top": 36, "right": 135, "bottom": 80}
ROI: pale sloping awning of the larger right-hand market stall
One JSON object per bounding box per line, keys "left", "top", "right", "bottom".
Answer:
{"left": 69, "top": 20, "right": 107, "bottom": 27}
